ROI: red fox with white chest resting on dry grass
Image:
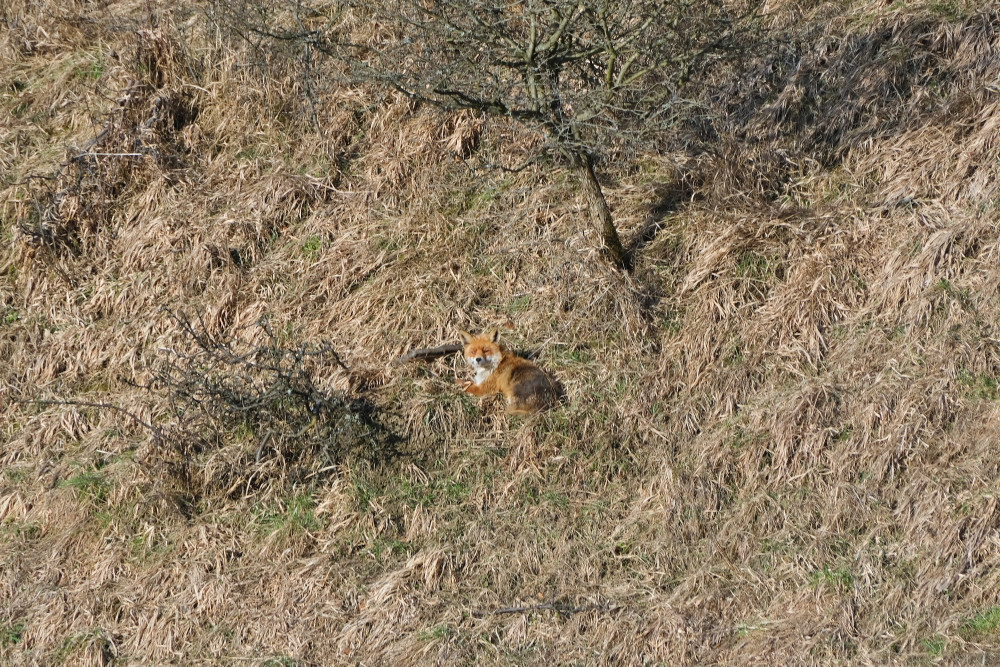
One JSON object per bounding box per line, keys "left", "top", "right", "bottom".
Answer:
{"left": 459, "top": 330, "right": 557, "bottom": 415}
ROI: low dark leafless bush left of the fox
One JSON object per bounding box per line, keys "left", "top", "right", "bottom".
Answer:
{"left": 144, "top": 313, "right": 398, "bottom": 504}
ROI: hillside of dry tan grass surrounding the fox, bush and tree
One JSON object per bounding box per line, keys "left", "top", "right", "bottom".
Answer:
{"left": 0, "top": 3, "right": 1000, "bottom": 664}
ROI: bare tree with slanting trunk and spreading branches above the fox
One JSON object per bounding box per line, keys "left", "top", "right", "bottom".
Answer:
{"left": 207, "top": 0, "right": 762, "bottom": 269}
